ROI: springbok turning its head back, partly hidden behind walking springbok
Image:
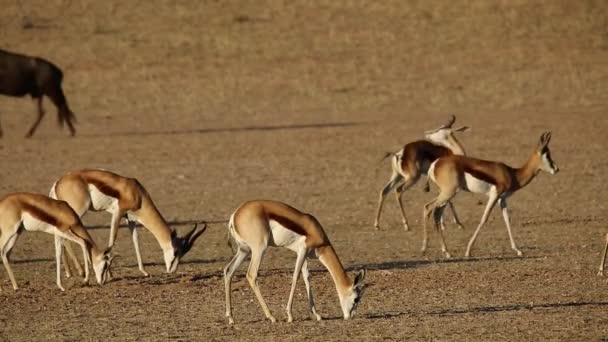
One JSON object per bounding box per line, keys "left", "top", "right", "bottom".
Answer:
{"left": 374, "top": 115, "right": 469, "bottom": 230}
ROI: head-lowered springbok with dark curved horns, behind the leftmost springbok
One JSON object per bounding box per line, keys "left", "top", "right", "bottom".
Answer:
{"left": 50, "top": 169, "right": 207, "bottom": 277}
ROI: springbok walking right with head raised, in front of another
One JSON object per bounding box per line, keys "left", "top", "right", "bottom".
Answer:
{"left": 422, "top": 132, "right": 559, "bottom": 258}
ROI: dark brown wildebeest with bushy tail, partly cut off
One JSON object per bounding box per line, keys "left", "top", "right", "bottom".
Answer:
{"left": 0, "top": 49, "right": 76, "bottom": 138}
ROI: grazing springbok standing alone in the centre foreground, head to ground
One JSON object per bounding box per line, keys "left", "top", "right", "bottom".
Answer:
{"left": 224, "top": 200, "right": 365, "bottom": 324}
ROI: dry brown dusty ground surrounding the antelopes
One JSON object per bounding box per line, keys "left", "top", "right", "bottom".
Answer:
{"left": 0, "top": 0, "right": 608, "bottom": 341}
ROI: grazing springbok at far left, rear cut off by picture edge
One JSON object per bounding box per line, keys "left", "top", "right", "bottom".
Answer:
{"left": 0, "top": 193, "right": 112, "bottom": 291}
